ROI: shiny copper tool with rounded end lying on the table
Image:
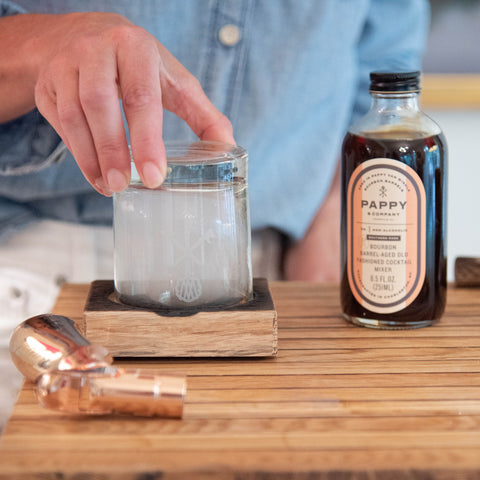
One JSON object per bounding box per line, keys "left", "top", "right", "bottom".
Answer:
{"left": 10, "top": 314, "right": 186, "bottom": 417}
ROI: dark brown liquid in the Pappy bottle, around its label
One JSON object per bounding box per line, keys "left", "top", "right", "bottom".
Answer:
{"left": 341, "top": 131, "right": 447, "bottom": 328}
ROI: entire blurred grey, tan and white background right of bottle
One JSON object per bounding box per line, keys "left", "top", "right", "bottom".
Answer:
{"left": 422, "top": 0, "right": 480, "bottom": 281}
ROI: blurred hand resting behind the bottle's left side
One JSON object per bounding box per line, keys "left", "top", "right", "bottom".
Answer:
{"left": 284, "top": 163, "right": 340, "bottom": 282}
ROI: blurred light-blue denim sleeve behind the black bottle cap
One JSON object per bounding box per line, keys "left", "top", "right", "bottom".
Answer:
{"left": 351, "top": 0, "right": 430, "bottom": 123}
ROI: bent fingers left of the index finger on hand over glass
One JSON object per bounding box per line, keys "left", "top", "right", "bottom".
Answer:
{"left": 35, "top": 47, "right": 130, "bottom": 196}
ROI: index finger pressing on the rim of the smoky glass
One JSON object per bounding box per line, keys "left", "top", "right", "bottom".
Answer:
{"left": 117, "top": 34, "right": 167, "bottom": 188}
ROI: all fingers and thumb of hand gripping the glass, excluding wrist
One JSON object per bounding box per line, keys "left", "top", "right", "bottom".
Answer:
{"left": 35, "top": 16, "right": 235, "bottom": 195}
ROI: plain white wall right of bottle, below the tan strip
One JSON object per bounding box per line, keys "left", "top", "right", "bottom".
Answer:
{"left": 426, "top": 110, "right": 480, "bottom": 281}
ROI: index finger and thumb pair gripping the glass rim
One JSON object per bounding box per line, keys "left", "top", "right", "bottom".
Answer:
{"left": 118, "top": 36, "right": 235, "bottom": 188}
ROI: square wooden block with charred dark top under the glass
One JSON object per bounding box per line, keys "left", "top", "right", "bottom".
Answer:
{"left": 78, "top": 278, "right": 277, "bottom": 357}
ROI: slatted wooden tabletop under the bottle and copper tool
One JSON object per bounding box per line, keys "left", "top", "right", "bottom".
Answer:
{"left": 0, "top": 283, "right": 480, "bottom": 480}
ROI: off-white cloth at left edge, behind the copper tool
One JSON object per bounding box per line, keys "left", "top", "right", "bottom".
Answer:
{"left": 0, "top": 220, "right": 113, "bottom": 431}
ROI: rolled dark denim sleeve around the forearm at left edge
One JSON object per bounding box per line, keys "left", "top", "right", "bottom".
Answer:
{"left": 0, "top": 0, "right": 67, "bottom": 176}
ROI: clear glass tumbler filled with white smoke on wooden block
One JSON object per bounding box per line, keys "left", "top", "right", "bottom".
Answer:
{"left": 114, "top": 141, "right": 253, "bottom": 310}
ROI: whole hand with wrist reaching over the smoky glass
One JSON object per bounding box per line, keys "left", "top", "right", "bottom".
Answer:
{"left": 0, "top": 12, "right": 235, "bottom": 195}
